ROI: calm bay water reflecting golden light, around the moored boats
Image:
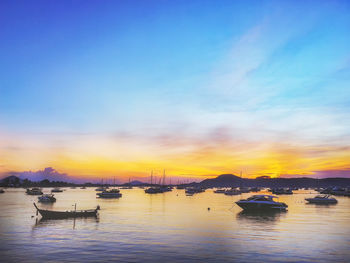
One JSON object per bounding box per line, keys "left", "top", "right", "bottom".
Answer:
{"left": 0, "top": 188, "right": 350, "bottom": 262}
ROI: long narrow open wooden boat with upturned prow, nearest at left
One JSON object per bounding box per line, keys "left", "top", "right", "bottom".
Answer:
{"left": 33, "top": 203, "right": 100, "bottom": 219}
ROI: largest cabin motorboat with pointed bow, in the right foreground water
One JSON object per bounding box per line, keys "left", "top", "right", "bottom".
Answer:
{"left": 236, "top": 195, "right": 288, "bottom": 210}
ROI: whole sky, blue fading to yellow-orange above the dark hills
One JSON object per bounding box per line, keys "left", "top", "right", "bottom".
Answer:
{"left": 0, "top": 0, "right": 350, "bottom": 181}
